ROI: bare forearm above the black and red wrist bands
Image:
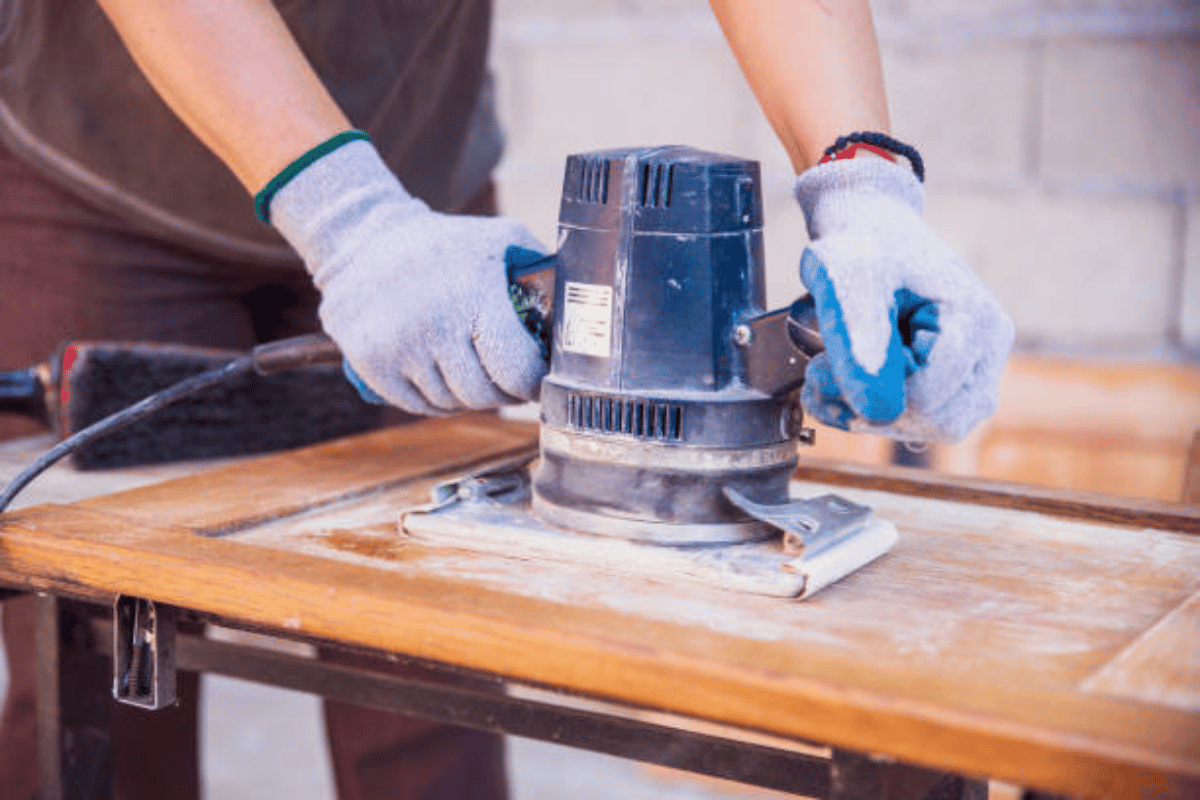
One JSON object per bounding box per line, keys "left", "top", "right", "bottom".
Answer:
{"left": 710, "top": 0, "right": 888, "bottom": 173}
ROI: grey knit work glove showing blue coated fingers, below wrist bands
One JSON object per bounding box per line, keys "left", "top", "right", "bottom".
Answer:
{"left": 796, "top": 157, "right": 1013, "bottom": 443}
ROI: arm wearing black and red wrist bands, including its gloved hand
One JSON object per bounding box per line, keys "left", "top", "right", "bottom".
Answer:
{"left": 712, "top": 0, "right": 1013, "bottom": 441}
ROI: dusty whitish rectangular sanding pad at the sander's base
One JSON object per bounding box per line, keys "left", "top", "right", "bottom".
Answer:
{"left": 400, "top": 462, "right": 898, "bottom": 600}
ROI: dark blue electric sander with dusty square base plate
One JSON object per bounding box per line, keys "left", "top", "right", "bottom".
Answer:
{"left": 401, "top": 146, "right": 896, "bottom": 597}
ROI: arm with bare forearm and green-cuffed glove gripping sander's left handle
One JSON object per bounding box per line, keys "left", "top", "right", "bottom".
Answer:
{"left": 100, "top": 0, "right": 546, "bottom": 414}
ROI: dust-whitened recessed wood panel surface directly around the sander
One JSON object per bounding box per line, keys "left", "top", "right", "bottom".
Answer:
{"left": 236, "top": 472, "right": 1200, "bottom": 705}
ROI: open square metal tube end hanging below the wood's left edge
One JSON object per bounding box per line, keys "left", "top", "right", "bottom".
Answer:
{"left": 113, "top": 596, "right": 176, "bottom": 710}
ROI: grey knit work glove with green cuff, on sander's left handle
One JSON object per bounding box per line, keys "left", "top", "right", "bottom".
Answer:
{"left": 270, "top": 140, "right": 547, "bottom": 415}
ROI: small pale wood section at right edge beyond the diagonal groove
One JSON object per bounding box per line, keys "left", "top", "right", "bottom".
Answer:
{"left": 1084, "top": 587, "right": 1200, "bottom": 711}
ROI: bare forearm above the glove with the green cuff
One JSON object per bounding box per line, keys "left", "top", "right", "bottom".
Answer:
{"left": 100, "top": 0, "right": 350, "bottom": 192}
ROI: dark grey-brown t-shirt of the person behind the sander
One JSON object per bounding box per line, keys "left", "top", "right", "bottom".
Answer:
{"left": 0, "top": 0, "right": 500, "bottom": 261}
